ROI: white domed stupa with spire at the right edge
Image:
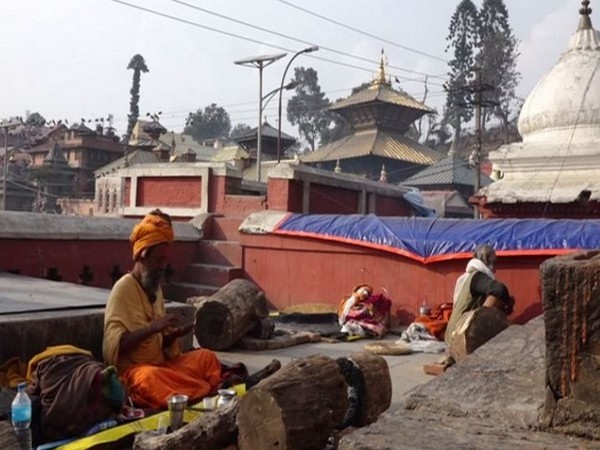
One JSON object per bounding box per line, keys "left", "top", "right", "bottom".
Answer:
{"left": 471, "top": 0, "right": 600, "bottom": 218}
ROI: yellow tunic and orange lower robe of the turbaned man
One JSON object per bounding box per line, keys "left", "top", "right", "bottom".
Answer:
{"left": 103, "top": 274, "right": 221, "bottom": 408}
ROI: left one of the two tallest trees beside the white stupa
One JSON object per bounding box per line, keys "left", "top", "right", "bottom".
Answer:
{"left": 444, "top": 0, "right": 478, "bottom": 148}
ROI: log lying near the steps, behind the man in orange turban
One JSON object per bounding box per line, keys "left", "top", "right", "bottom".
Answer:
{"left": 194, "top": 279, "right": 269, "bottom": 350}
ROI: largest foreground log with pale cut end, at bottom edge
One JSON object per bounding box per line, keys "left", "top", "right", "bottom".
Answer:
{"left": 238, "top": 355, "right": 348, "bottom": 450}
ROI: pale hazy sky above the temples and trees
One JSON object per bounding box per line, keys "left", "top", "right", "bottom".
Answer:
{"left": 0, "top": 0, "right": 580, "bottom": 135}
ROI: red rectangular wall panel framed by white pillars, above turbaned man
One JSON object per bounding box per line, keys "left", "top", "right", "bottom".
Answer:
{"left": 136, "top": 177, "right": 202, "bottom": 208}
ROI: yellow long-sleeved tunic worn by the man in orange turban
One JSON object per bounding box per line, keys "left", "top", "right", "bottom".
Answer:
{"left": 102, "top": 274, "right": 181, "bottom": 373}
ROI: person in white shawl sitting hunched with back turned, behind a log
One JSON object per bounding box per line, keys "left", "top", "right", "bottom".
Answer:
{"left": 445, "top": 244, "right": 514, "bottom": 344}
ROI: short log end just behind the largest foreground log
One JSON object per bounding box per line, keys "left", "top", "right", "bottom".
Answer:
{"left": 349, "top": 352, "right": 392, "bottom": 427}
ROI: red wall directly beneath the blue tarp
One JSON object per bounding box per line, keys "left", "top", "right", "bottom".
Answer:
{"left": 240, "top": 234, "right": 547, "bottom": 325}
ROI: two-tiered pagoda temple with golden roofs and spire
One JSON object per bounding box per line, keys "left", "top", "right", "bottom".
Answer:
{"left": 300, "top": 55, "right": 444, "bottom": 183}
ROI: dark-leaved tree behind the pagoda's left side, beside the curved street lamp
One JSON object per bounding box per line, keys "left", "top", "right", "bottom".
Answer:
{"left": 287, "top": 67, "right": 332, "bottom": 151}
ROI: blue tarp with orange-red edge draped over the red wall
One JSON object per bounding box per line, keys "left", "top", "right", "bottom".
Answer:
{"left": 274, "top": 214, "right": 600, "bottom": 263}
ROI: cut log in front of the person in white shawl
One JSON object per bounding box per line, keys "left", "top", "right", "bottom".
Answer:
{"left": 448, "top": 307, "right": 510, "bottom": 361}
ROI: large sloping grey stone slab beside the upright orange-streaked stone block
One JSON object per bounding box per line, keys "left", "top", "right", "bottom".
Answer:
{"left": 339, "top": 317, "right": 600, "bottom": 450}
